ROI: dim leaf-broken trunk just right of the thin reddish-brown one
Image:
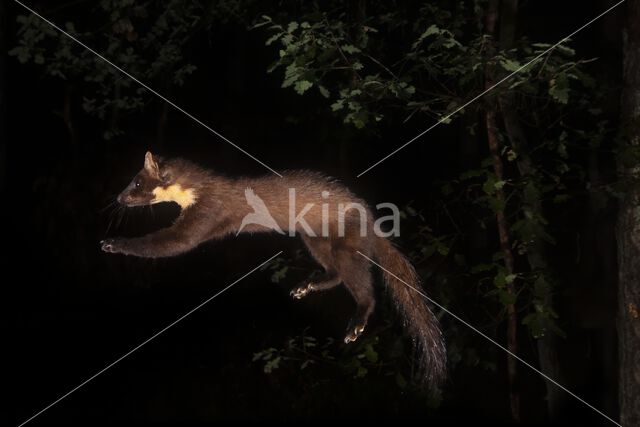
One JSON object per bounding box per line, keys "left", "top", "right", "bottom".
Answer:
{"left": 499, "top": 0, "right": 566, "bottom": 421}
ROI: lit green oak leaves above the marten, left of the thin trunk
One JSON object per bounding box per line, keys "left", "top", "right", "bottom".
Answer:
{"left": 255, "top": 2, "right": 478, "bottom": 129}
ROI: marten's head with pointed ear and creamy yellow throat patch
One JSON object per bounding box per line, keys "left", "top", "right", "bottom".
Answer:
{"left": 118, "top": 151, "right": 196, "bottom": 209}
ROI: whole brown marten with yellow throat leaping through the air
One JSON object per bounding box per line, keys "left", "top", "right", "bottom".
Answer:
{"left": 101, "top": 152, "right": 446, "bottom": 385}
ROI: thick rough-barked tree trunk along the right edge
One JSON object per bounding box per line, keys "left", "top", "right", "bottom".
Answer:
{"left": 616, "top": 0, "right": 640, "bottom": 426}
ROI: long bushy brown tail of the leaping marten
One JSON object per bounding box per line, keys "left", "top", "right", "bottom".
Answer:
{"left": 375, "top": 238, "right": 447, "bottom": 386}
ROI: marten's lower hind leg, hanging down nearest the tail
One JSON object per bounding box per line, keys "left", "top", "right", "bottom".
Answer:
{"left": 336, "top": 248, "right": 375, "bottom": 344}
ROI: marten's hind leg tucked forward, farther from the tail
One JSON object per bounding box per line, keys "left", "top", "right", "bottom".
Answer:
{"left": 291, "top": 235, "right": 342, "bottom": 299}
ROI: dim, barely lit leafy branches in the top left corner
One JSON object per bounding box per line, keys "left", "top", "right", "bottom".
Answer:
{"left": 9, "top": 0, "right": 251, "bottom": 139}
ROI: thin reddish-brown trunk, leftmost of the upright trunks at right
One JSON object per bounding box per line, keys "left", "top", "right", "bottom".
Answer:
{"left": 485, "top": 0, "right": 520, "bottom": 421}
